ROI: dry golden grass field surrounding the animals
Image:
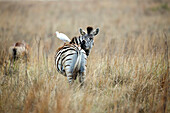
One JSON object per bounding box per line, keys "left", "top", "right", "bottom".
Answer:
{"left": 0, "top": 0, "right": 170, "bottom": 113}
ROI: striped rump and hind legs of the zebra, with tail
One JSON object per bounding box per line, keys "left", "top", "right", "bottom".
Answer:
{"left": 55, "top": 44, "right": 87, "bottom": 84}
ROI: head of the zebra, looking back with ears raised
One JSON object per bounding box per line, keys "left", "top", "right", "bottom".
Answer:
{"left": 80, "top": 27, "right": 99, "bottom": 56}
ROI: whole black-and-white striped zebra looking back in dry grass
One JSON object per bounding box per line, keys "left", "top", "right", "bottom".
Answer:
{"left": 55, "top": 27, "right": 99, "bottom": 86}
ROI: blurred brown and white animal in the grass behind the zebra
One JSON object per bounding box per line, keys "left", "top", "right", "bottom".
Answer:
{"left": 9, "top": 41, "right": 30, "bottom": 61}
